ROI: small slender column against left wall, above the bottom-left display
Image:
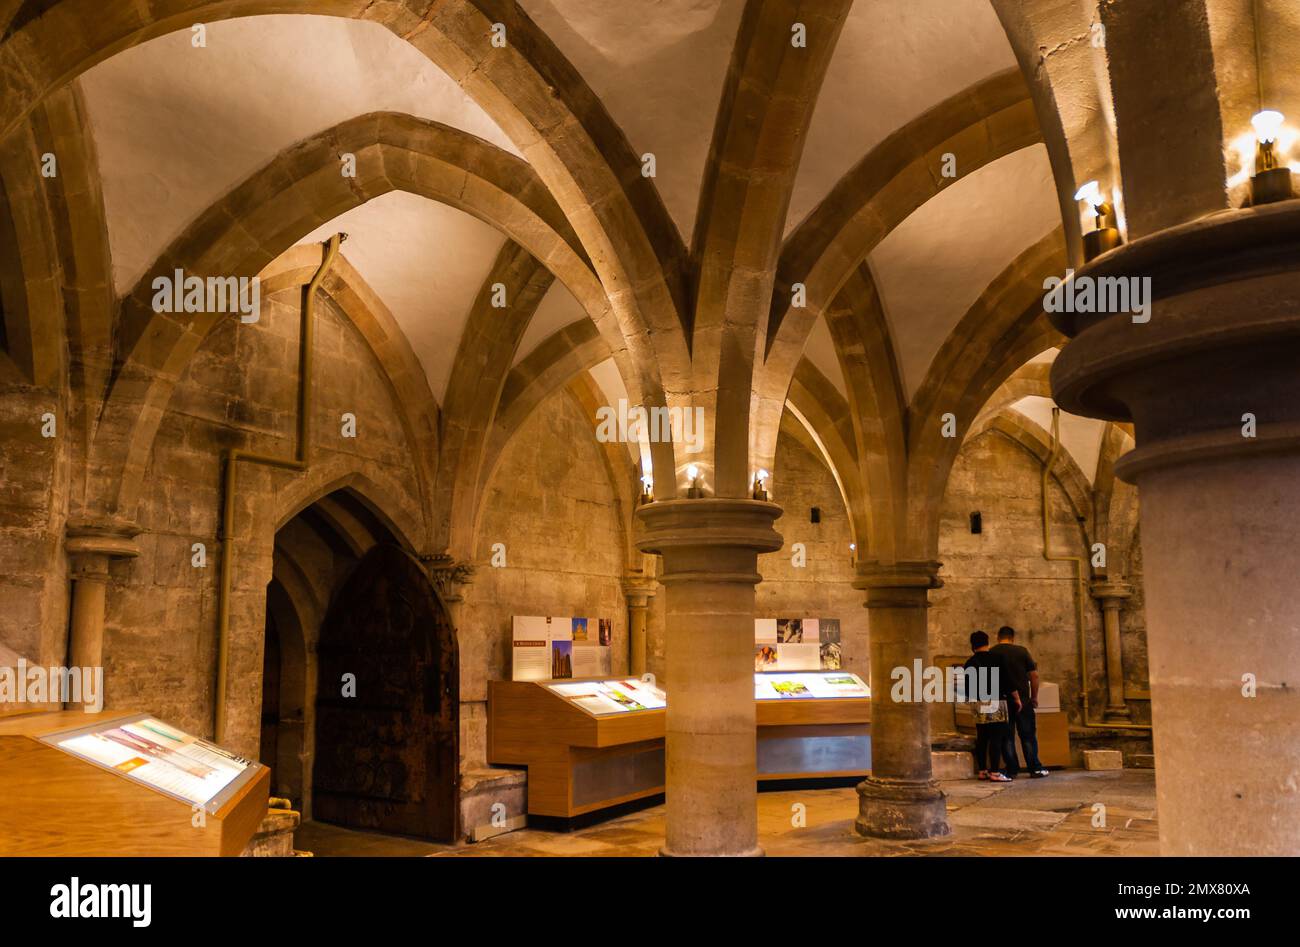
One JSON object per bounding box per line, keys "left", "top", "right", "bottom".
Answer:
{"left": 64, "top": 526, "right": 140, "bottom": 710}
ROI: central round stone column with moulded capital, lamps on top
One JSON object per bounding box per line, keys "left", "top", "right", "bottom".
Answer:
{"left": 637, "top": 498, "right": 781, "bottom": 855}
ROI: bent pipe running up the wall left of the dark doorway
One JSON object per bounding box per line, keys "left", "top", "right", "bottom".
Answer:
{"left": 212, "top": 233, "right": 347, "bottom": 744}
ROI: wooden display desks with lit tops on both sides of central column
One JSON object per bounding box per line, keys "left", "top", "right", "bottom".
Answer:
{"left": 488, "top": 671, "right": 871, "bottom": 820}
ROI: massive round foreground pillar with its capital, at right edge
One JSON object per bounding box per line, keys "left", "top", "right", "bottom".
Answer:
{"left": 1052, "top": 209, "right": 1300, "bottom": 855}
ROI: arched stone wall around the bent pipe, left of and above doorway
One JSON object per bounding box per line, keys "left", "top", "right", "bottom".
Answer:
{"left": 104, "top": 280, "right": 423, "bottom": 756}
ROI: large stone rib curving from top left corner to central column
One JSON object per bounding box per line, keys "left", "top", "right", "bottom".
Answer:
{"left": 0, "top": 0, "right": 690, "bottom": 487}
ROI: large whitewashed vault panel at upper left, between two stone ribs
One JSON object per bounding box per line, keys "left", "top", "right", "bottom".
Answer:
{"left": 81, "top": 16, "right": 517, "bottom": 293}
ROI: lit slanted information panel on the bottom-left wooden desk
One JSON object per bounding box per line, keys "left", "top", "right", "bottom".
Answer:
{"left": 40, "top": 714, "right": 260, "bottom": 813}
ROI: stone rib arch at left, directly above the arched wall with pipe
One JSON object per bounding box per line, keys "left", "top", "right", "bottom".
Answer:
{"left": 85, "top": 113, "right": 603, "bottom": 525}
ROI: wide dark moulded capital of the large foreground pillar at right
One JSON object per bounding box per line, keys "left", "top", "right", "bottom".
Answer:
{"left": 1050, "top": 200, "right": 1300, "bottom": 483}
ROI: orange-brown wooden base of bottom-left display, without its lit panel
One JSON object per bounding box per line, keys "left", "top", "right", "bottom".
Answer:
{"left": 0, "top": 710, "right": 270, "bottom": 856}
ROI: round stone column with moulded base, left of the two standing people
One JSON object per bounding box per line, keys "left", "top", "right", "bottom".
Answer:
{"left": 853, "top": 561, "right": 949, "bottom": 839}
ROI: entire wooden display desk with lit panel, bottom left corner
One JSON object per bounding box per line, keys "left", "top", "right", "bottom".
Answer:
{"left": 0, "top": 710, "right": 270, "bottom": 856}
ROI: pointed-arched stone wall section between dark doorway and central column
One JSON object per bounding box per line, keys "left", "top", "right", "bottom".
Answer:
{"left": 460, "top": 390, "right": 628, "bottom": 767}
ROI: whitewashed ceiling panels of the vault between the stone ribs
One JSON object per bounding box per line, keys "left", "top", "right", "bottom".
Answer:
{"left": 63, "top": 0, "right": 1091, "bottom": 457}
